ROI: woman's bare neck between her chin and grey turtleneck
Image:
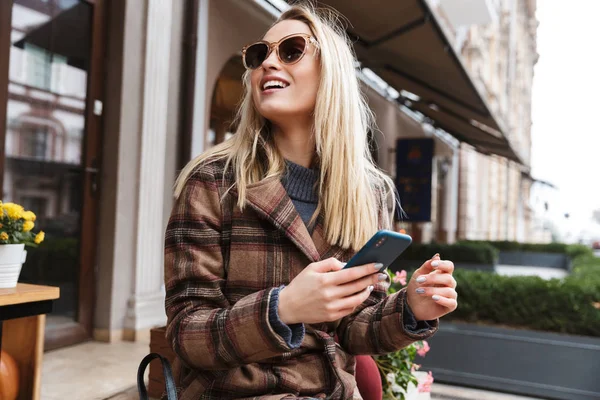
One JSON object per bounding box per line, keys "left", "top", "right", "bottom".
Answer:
{"left": 273, "top": 123, "right": 315, "bottom": 168}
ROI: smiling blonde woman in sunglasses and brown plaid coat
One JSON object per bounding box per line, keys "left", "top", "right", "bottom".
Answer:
{"left": 165, "top": 6, "right": 456, "bottom": 399}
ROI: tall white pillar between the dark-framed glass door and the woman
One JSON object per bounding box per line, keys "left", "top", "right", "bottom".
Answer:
{"left": 125, "top": 0, "right": 173, "bottom": 337}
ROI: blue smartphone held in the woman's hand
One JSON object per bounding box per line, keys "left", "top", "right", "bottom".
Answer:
{"left": 344, "top": 229, "right": 412, "bottom": 272}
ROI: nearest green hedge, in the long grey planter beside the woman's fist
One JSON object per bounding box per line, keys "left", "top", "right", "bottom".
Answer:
{"left": 444, "top": 249, "right": 600, "bottom": 336}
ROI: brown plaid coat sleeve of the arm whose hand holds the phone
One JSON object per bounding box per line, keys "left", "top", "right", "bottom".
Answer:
{"left": 165, "top": 167, "right": 298, "bottom": 369}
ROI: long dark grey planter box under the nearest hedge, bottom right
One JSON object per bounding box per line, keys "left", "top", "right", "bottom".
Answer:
{"left": 418, "top": 322, "right": 600, "bottom": 400}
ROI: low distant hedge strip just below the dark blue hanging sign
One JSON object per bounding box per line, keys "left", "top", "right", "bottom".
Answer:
{"left": 401, "top": 243, "right": 498, "bottom": 264}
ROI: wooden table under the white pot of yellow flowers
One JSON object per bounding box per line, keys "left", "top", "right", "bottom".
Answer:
{"left": 0, "top": 283, "right": 60, "bottom": 400}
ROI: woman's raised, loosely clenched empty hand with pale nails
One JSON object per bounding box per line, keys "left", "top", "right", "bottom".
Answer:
{"left": 406, "top": 254, "right": 458, "bottom": 321}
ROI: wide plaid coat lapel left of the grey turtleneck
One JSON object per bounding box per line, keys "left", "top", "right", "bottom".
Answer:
{"left": 246, "top": 178, "right": 321, "bottom": 262}
